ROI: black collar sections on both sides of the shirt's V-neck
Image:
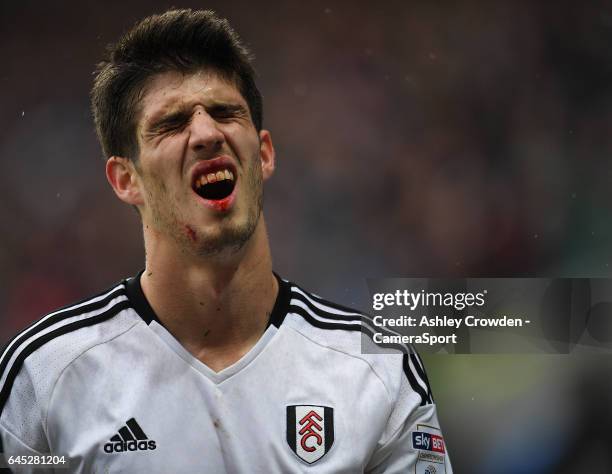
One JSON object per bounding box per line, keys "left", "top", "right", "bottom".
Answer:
{"left": 125, "top": 270, "right": 291, "bottom": 328}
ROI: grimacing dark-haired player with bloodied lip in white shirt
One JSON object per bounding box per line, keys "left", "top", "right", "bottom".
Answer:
{"left": 0, "top": 10, "right": 451, "bottom": 473}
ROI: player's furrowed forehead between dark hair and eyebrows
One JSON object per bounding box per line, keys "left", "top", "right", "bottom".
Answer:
{"left": 140, "top": 71, "right": 246, "bottom": 121}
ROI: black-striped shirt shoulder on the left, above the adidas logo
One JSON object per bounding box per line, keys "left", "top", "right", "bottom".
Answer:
{"left": 0, "top": 281, "right": 138, "bottom": 413}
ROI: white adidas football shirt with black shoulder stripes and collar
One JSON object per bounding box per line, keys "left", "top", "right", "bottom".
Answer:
{"left": 0, "top": 276, "right": 452, "bottom": 474}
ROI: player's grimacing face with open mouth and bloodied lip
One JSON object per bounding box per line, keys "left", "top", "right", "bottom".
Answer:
{"left": 130, "top": 72, "right": 274, "bottom": 255}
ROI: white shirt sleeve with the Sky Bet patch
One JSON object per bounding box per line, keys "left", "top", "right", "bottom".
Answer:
{"left": 365, "top": 354, "right": 453, "bottom": 474}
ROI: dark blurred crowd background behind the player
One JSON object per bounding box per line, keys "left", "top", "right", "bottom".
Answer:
{"left": 0, "top": 0, "right": 612, "bottom": 474}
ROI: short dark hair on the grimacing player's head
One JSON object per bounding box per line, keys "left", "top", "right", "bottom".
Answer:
{"left": 91, "top": 9, "right": 263, "bottom": 159}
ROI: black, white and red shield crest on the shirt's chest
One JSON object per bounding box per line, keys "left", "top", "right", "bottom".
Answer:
{"left": 287, "top": 405, "right": 334, "bottom": 464}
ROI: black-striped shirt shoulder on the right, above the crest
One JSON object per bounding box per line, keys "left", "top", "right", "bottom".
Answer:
{"left": 284, "top": 280, "right": 433, "bottom": 406}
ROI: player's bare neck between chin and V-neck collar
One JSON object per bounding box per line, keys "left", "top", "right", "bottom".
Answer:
{"left": 141, "top": 216, "right": 278, "bottom": 371}
